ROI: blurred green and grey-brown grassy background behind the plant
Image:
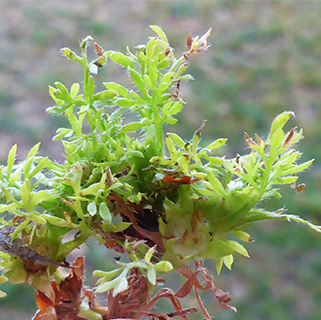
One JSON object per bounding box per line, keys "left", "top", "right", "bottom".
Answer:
{"left": 0, "top": 0, "right": 321, "bottom": 320}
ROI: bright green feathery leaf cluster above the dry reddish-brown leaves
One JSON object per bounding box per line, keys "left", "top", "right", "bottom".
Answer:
{"left": 0, "top": 26, "right": 321, "bottom": 318}
